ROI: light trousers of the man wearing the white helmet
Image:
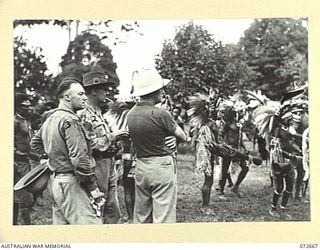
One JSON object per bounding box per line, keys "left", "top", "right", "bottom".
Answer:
{"left": 133, "top": 155, "right": 177, "bottom": 223}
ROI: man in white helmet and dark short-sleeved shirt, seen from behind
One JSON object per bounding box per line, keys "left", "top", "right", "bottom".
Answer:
{"left": 128, "top": 68, "right": 191, "bottom": 223}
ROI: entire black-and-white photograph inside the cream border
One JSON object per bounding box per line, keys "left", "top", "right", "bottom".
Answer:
{"left": 13, "top": 16, "right": 314, "bottom": 227}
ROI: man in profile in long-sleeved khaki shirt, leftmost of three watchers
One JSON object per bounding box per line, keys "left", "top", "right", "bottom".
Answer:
{"left": 31, "top": 77, "right": 104, "bottom": 224}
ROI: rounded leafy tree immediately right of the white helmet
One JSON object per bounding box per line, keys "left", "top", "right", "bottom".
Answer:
{"left": 156, "top": 22, "right": 255, "bottom": 103}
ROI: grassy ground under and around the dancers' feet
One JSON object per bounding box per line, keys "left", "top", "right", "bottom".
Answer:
{"left": 19, "top": 142, "right": 311, "bottom": 225}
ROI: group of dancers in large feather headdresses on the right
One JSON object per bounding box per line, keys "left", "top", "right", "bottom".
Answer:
{"left": 188, "top": 88, "right": 308, "bottom": 219}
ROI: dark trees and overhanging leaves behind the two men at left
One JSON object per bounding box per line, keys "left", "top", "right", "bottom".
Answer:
{"left": 13, "top": 19, "right": 139, "bottom": 102}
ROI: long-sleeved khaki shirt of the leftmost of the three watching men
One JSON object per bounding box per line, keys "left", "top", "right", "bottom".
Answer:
{"left": 30, "top": 104, "right": 95, "bottom": 176}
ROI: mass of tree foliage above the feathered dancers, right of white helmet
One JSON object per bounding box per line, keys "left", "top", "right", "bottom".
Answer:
{"left": 155, "top": 18, "right": 308, "bottom": 103}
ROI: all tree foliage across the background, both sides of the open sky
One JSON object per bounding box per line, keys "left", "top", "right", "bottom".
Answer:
{"left": 14, "top": 18, "right": 308, "bottom": 107}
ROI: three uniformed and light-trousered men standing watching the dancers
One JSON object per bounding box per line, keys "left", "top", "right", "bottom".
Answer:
{"left": 15, "top": 68, "right": 191, "bottom": 224}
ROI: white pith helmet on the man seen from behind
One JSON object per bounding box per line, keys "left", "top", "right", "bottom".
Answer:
{"left": 132, "top": 67, "right": 170, "bottom": 96}
